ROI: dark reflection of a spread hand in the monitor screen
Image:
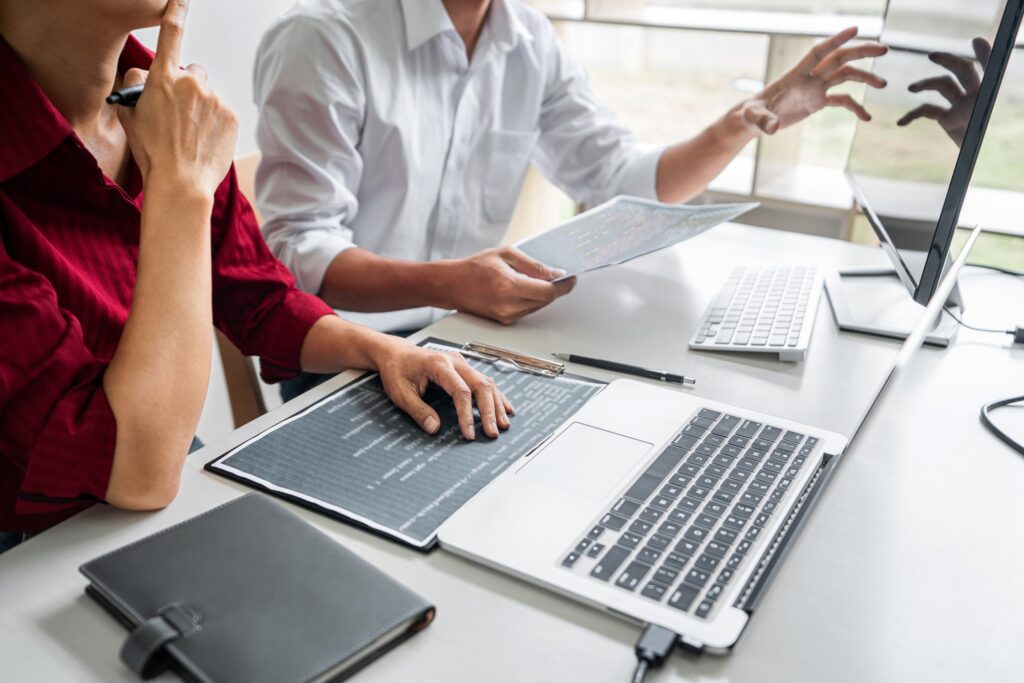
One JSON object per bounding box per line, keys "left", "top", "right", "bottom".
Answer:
{"left": 896, "top": 38, "right": 992, "bottom": 146}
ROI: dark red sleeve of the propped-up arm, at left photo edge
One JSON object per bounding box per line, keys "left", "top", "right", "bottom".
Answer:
{"left": 0, "top": 243, "right": 117, "bottom": 518}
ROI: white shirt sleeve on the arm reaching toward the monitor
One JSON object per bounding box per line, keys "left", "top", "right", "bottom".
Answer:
{"left": 534, "top": 25, "right": 665, "bottom": 206}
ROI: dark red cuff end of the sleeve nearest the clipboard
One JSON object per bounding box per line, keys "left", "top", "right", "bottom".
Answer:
{"left": 260, "top": 289, "right": 335, "bottom": 384}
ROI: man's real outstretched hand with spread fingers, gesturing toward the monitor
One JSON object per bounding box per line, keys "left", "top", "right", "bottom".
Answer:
{"left": 740, "top": 27, "right": 889, "bottom": 135}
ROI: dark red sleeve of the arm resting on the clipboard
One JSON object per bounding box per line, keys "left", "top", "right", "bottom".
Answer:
{"left": 212, "top": 163, "right": 334, "bottom": 382}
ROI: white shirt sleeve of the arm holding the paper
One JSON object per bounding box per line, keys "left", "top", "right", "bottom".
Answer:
{"left": 253, "top": 16, "right": 368, "bottom": 294}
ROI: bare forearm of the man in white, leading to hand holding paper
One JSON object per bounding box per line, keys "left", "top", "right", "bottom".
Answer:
{"left": 318, "top": 247, "right": 452, "bottom": 312}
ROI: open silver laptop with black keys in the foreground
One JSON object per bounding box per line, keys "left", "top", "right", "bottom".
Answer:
{"left": 438, "top": 230, "right": 977, "bottom": 653}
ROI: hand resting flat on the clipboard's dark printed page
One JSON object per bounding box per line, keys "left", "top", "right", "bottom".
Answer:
{"left": 377, "top": 340, "right": 515, "bottom": 439}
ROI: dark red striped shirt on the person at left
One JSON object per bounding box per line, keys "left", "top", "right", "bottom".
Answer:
{"left": 0, "top": 37, "right": 333, "bottom": 531}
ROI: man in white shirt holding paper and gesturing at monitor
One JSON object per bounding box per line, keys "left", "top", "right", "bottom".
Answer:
{"left": 255, "top": 0, "right": 886, "bottom": 397}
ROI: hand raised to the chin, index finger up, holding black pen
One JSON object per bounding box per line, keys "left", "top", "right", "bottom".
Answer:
{"left": 118, "top": 0, "right": 238, "bottom": 197}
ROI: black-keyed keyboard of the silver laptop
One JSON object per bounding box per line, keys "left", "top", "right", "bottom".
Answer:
{"left": 561, "top": 409, "right": 819, "bottom": 618}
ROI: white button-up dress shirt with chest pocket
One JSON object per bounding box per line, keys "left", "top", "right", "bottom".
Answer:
{"left": 254, "top": 0, "right": 662, "bottom": 331}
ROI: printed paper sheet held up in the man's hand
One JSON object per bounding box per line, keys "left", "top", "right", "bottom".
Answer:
{"left": 516, "top": 197, "right": 758, "bottom": 279}
